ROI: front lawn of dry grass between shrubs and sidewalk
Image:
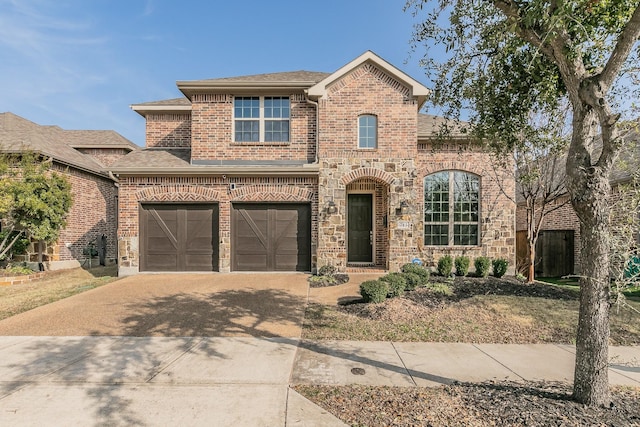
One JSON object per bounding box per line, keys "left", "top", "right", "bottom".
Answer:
{"left": 303, "top": 278, "right": 640, "bottom": 345}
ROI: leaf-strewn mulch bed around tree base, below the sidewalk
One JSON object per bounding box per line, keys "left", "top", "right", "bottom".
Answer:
{"left": 294, "top": 382, "right": 640, "bottom": 427}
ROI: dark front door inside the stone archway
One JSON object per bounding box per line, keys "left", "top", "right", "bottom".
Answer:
{"left": 347, "top": 194, "right": 373, "bottom": 263}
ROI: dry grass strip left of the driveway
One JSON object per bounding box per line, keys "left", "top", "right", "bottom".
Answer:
{"left": 0, "top": 266, "right": 117, "bottom": 320}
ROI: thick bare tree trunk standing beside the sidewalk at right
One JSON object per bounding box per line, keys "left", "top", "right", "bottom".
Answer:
{"left": 572, "top": 173, "right": 610, "bottom": 406}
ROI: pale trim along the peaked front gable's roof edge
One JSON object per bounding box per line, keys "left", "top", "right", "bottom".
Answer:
{"left": 307, "top": 50, "right": 431, "bottom": 106}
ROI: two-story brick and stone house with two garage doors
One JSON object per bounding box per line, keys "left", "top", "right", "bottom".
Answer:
{"left": 111, "top": 51, "right": 515, "bottom": 275}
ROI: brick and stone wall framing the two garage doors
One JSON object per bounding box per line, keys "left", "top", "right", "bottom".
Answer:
{"left": 118, "top": 176, "right": 318, "bottom": 275}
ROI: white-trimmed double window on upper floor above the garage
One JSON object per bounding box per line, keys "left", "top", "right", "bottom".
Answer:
{"left": 233, "top": 96, "right": 290, "bottom": 142}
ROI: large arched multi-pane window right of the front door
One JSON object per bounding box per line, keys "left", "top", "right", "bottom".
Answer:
{"left": 424, "top": 171, "right": 480, "bottom": 246}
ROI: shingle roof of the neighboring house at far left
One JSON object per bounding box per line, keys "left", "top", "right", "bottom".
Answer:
{"left": 0, "top": 113, "right": 137, "bottom": 175}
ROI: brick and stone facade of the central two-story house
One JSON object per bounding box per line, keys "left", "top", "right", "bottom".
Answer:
{"left": 118, "top": 55, "right": 515, "bottom": 271}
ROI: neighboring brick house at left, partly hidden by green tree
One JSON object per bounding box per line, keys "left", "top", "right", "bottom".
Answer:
{"left": 0, "top": 113, "right": 139, "bottom": 269}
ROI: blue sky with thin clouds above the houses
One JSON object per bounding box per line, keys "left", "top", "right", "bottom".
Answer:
{"left": 0, "top": 0, "right": 436, "bottom": 145}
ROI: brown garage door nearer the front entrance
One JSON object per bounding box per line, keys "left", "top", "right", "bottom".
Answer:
{"left": 231, "top": 203, "right": 311, "bottom": 271}
